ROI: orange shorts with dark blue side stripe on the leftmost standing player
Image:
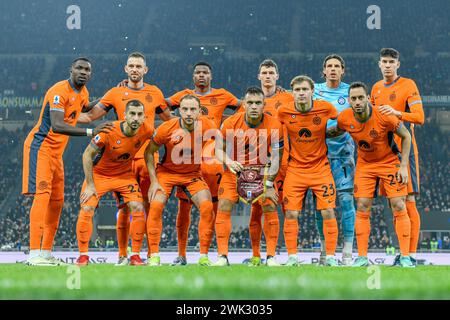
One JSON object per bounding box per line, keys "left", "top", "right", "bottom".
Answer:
{"left": 22, "top": 144, "right": 64, "bottom": 200}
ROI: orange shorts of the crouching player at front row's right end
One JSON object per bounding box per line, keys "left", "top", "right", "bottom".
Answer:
{"left": 354, "top": 164, "right": 408, "bottom": 198}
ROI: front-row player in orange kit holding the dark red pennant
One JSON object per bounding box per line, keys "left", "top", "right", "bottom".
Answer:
{"left": 214, "top": 87, "right": 284, "bottom": 267}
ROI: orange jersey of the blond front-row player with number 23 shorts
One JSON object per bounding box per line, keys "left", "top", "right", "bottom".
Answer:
{"left": 278, "top": 100, "right": 338, "bottom": 172}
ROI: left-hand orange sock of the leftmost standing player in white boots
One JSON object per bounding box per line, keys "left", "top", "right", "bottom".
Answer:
{"left": 30, "top": 193, "right": 50, "bottom": 250}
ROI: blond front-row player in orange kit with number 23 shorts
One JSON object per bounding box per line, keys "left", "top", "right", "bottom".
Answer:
{"left": 278, "top": 76, "right": 338, "bottom": 266}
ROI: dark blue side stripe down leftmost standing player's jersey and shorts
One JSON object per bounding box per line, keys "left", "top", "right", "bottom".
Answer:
{"left": 28, "top": 103, "right": 51, "bottom": 193}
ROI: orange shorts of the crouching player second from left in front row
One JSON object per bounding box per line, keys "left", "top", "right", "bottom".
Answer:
{"left": 156, "top": 166, "right": 209, "bottom": 199}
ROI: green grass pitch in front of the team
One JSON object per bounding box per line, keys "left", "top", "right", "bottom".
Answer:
{"left": 0, "top": 264, "right": 450, "bottom": 300}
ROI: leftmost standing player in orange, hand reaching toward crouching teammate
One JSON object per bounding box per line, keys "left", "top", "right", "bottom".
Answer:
{"left": 22, "top": 57, "right": 109, "bottom": 266}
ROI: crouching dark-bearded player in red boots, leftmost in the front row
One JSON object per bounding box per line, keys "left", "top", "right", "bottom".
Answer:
{"left": 76, "top": 100, "right": 153, "bottom": 266}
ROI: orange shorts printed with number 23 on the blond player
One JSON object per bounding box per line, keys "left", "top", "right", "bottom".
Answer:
{"left": 283, "top": 166, "right": 336, "bottom": 211}
